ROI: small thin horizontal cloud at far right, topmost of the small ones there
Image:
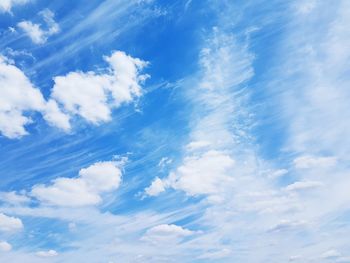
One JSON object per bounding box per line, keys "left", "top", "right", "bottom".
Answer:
{"left": 293, "top": 155, "right": 337, "bottom": 169}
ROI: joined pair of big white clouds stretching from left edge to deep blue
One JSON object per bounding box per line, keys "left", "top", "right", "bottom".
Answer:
{"left": 0, "top": 51, "right": 148, "bottom": 138}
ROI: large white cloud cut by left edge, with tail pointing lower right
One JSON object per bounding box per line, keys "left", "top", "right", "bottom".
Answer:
{"left": 0, "top": 56, "right": 69, "bottom": 138}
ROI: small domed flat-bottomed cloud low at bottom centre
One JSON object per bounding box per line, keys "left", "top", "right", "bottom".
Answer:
{"left": 141, "top": 224, "right": 195, "bottom": 244}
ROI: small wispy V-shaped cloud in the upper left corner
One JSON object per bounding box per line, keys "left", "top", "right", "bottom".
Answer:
{"left": 17, "top": 9, "right": 60, "bottom": 44}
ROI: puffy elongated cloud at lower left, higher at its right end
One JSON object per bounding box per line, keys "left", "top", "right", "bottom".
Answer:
{"left": 31, "top": 162, "right": 122, "bottom": 207}
